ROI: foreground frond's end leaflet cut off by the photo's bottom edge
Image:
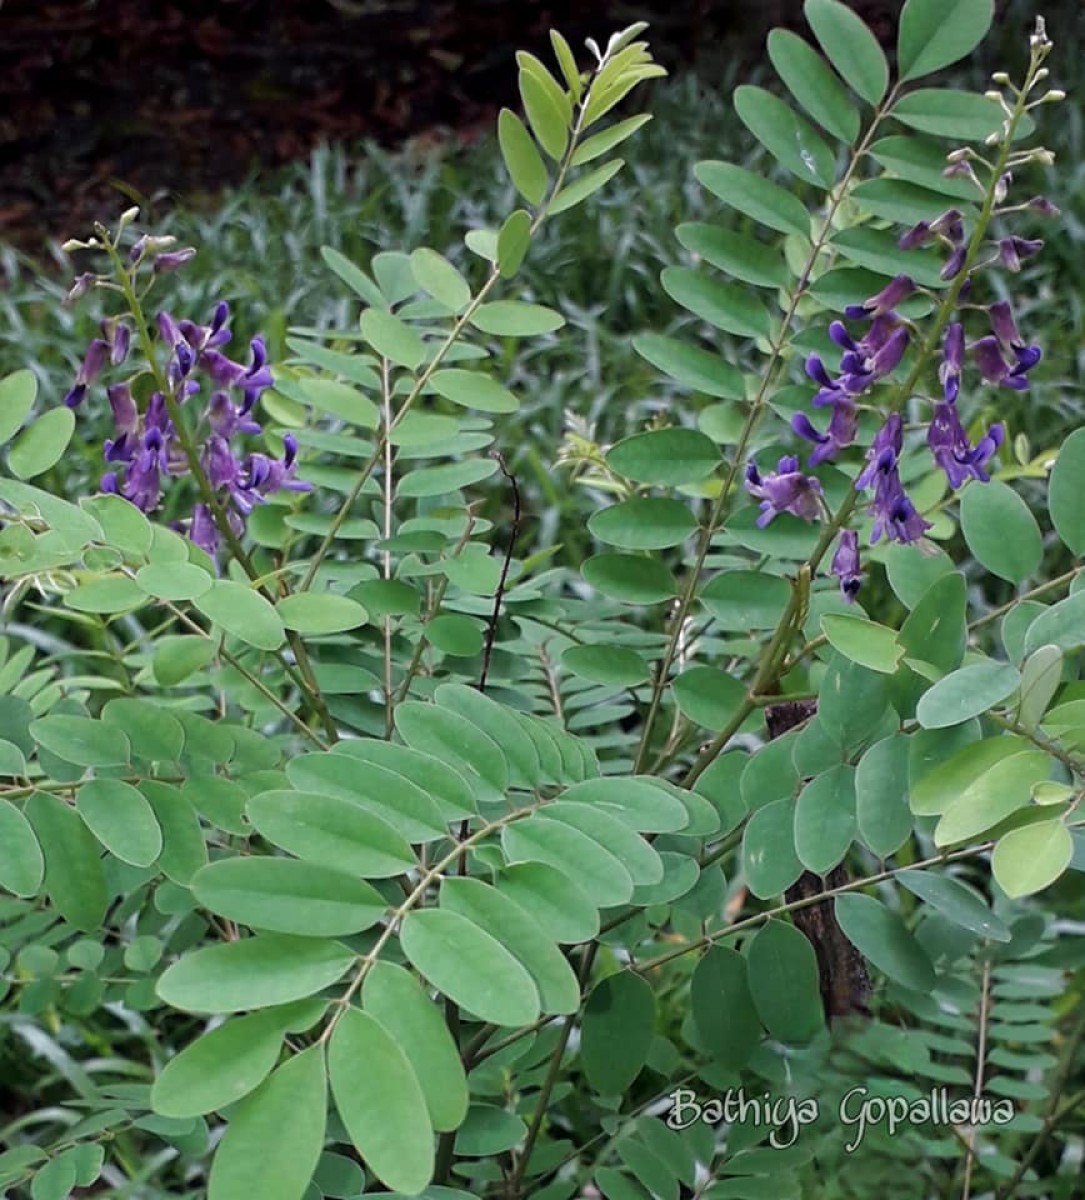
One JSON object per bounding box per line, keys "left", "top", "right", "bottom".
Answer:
{"left": 208, "top": 1044, "right": 328, "bottom": 1200}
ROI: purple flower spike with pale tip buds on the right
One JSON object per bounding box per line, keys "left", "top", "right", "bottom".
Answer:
{"left": 745, "top": 25, "right": 1062, "bottom": 601}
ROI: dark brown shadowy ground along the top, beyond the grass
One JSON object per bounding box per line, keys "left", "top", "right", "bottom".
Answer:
{"left": 0, "top": 0, "right": 1065, "bottom": 254}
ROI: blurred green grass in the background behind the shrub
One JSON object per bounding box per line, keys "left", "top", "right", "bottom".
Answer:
{"left": 0, "top": 53, "right": 1085, "bottom": 560}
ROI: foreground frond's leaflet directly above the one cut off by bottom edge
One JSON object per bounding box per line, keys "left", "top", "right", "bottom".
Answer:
{"left": 151, "top": 1008, "right": 292, "bottom": 1120}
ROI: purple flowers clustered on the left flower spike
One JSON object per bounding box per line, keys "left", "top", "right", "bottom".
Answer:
{"left": 65, "top": 300, "right": 312, "bottom": 556}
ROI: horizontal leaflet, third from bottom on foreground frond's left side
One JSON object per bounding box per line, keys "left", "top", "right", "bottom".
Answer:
{"left": 156, "top": 934, "right": 356, "bottom": 1013}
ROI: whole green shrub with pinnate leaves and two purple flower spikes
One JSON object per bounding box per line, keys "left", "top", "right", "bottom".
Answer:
{"left": 0, "top": 0, "right": 1085, "bottom": 1200}
